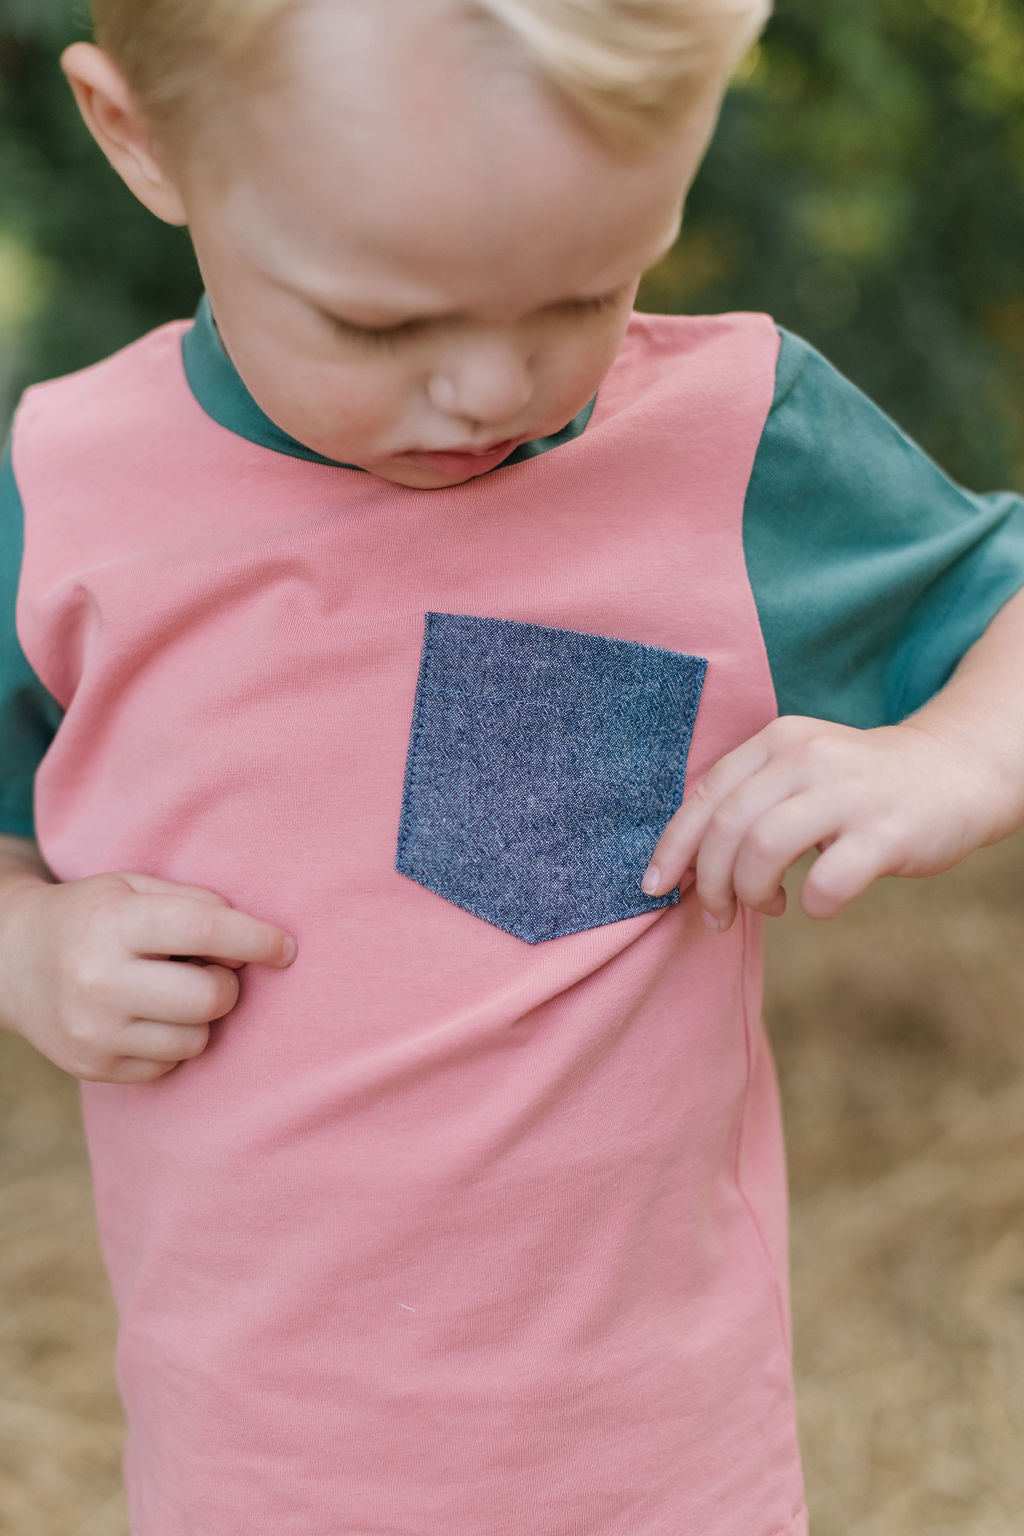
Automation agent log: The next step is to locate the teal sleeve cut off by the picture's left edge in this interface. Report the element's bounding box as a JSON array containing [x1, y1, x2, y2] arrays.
[[0, 433, 63, 837]]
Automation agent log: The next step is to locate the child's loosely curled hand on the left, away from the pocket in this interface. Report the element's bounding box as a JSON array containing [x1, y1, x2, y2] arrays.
[[0, 872, 295, 1083]]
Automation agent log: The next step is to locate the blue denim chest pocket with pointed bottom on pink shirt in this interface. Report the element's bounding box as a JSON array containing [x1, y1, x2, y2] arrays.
[[395, 613, 708, 945]]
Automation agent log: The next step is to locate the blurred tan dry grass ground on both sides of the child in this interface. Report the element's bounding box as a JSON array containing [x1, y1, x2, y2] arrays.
[[0, 837, 1024, 1536]]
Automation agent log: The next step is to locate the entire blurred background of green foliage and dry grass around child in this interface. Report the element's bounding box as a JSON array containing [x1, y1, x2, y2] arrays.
[[0, 0, 1024, 1536]]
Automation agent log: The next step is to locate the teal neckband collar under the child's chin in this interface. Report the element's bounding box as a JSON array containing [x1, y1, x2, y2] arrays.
[[181, 293, 597, 475]]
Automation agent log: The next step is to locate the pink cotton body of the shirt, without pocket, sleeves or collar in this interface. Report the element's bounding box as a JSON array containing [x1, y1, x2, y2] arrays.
[[14, 315, 806, 1536]]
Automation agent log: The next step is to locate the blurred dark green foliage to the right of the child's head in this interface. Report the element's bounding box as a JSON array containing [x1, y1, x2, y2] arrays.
[[643, 0, 1024, 485]]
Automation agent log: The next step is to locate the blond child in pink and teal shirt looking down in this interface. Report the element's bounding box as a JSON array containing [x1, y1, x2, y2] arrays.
[[0, 0, 1024, 1536]]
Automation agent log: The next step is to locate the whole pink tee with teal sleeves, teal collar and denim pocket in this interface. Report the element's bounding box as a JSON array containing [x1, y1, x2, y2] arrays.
[[0, 307, 1024, 1536]]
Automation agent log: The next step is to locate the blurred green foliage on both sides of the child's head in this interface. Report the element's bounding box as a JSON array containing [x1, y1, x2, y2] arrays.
[[0, 0, 1024, 487]]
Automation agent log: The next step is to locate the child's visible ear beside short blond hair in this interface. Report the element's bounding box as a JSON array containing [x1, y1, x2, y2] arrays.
[[60, 43, 187, 224]]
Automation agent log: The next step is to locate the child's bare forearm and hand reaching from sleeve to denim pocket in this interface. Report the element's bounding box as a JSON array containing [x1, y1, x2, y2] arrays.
[[645, 591, 1024, 929]]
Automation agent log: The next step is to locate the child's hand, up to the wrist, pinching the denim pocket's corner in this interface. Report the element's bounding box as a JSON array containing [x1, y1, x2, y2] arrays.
[[645, 714, 1006, 931]]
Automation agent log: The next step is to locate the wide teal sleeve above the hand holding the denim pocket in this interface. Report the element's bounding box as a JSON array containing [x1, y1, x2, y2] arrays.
[[743, 330, 1024, 727]]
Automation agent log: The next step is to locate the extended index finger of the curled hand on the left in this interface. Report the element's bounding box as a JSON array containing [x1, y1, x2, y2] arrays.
[[126, 894, 298, 969]]
